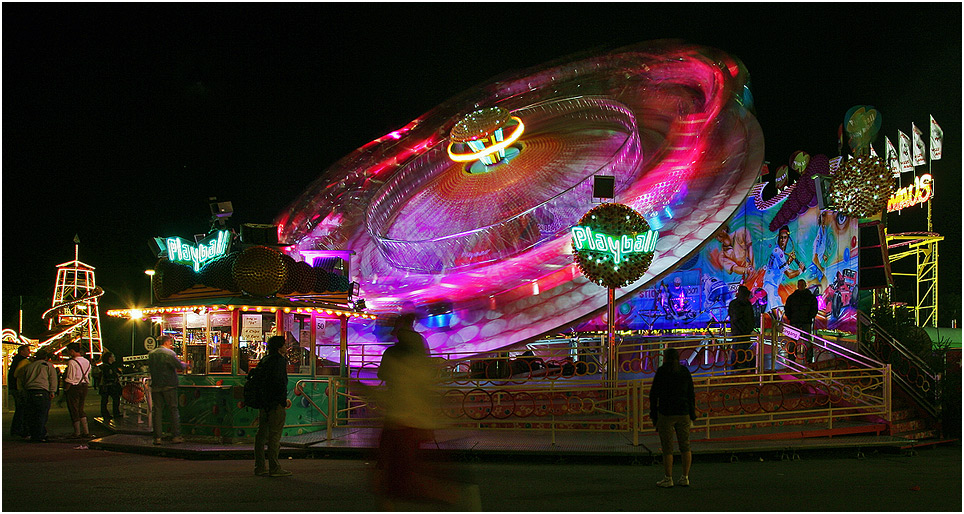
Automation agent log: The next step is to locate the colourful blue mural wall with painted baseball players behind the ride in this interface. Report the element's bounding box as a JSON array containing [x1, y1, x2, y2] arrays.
[[577, 195, 857, 332]]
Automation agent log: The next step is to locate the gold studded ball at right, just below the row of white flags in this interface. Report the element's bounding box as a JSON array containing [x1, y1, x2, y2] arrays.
[[829, 156, 894, 218]]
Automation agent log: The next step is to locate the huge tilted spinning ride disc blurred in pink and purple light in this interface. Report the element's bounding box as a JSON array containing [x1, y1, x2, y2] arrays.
[[276, 41, 763, 353]]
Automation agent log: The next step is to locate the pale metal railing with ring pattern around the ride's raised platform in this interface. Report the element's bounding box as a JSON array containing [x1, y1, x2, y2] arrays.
[[296, 324, 891, 444]]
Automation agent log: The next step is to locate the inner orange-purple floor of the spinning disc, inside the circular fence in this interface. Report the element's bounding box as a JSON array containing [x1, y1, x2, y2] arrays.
[[368, 97, 639, 273]]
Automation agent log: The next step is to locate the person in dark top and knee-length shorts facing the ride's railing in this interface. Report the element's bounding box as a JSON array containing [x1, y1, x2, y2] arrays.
[[649, 348, 696, 487]]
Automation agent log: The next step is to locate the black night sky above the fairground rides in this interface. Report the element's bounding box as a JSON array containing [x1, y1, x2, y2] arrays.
[[2, 3, 962, 352]]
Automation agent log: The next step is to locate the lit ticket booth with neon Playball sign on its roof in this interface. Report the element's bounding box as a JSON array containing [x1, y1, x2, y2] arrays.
[[108, 231, 375, 442]]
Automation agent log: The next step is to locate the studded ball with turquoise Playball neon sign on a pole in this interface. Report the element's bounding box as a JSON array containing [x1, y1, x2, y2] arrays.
[[572, 203, 658, 287]]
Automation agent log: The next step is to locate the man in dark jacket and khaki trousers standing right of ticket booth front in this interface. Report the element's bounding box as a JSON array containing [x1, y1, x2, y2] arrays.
[[254, 336, 291, 477]]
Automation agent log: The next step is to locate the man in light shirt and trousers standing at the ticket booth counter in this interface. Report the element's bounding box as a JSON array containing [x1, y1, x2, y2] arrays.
[[147, 335, 187, 444]]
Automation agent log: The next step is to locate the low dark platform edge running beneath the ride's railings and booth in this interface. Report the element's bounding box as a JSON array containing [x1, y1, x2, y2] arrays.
[[88, 418, 911, 463]]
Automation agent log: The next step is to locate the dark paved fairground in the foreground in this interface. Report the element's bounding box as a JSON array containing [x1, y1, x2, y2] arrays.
[[2, 388, 962, 512]]
